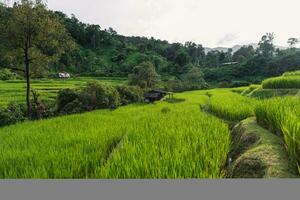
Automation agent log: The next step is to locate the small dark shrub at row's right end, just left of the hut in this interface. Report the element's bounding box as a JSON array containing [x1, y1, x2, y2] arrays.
[[117, 85, 143, 105]]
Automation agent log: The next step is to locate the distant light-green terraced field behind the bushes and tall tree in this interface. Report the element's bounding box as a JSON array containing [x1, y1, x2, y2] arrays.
[[0, 77, 126, 107]]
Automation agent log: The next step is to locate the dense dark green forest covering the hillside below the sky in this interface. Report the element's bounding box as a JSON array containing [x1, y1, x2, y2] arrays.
[[0, 1, 300, 86]]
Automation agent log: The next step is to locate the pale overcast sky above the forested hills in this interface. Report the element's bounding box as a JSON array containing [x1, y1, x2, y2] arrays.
[[48, 0, 300, 47]]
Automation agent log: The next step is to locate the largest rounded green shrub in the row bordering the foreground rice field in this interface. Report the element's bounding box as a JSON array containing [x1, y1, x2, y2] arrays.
[[79, 81, 120, 111]]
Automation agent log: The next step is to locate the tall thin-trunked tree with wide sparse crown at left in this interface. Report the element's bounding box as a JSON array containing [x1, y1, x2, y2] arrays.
[[5, 0, 74, 116]]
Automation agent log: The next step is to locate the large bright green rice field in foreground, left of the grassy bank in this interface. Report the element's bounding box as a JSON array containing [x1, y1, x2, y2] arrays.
[[0, 92, 230, 178]]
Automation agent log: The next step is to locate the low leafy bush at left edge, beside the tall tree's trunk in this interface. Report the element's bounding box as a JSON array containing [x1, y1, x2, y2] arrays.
[[0, 103, 26, 127]]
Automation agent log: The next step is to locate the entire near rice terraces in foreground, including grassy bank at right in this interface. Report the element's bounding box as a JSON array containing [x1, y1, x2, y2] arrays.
[[0, 72, 300, 178]]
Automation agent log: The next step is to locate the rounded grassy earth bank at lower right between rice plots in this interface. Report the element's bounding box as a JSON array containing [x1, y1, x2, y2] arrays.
[[228, 118, 297, 178]]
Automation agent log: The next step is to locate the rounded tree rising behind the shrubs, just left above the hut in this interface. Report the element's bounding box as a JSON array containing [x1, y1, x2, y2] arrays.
[[129, 62, 159, 88]]
